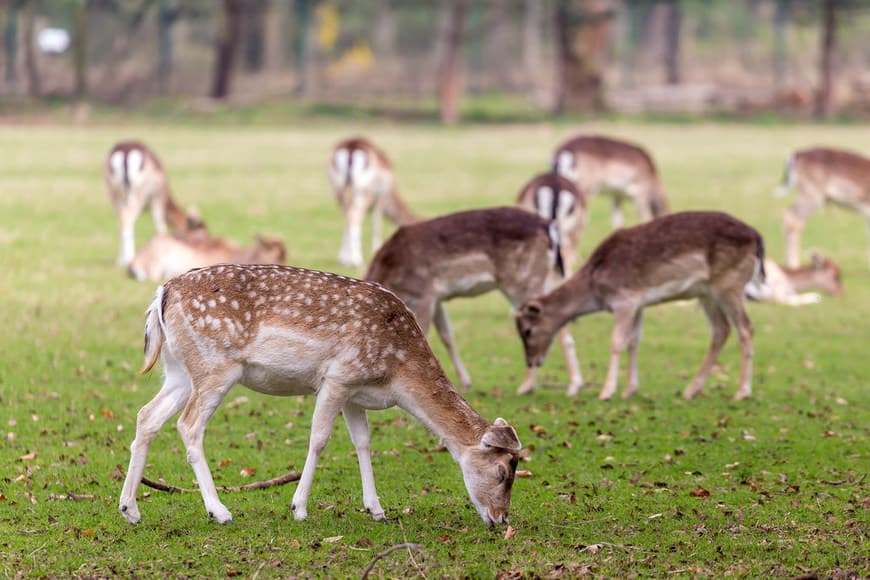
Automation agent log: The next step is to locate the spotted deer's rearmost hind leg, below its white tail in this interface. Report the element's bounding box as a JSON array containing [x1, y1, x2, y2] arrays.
[[118, 351, 190, 524]]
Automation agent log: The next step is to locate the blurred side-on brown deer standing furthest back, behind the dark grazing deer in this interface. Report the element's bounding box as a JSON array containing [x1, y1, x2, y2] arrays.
[[553, 135, 668, 229]]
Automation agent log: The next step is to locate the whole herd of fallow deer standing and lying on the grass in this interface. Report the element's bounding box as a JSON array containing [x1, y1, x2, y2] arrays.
[[104, 135, 870, 525]]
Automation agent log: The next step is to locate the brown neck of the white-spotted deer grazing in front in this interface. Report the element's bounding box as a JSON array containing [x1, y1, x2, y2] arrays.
[[397, 368, 489, 461]]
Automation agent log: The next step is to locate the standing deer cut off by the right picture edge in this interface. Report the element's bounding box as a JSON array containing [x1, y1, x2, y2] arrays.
[[776, 147, 870, 268]]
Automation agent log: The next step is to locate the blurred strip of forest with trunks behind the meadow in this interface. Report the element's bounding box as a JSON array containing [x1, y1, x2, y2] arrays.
[[0, 0, 870, 122]]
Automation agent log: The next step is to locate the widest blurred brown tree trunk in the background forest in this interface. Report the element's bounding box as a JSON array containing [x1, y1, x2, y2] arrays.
[[555, 0, 613, 114]]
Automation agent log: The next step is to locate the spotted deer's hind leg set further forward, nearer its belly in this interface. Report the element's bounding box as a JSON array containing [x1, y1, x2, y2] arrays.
[[177, 369, 238, 524]]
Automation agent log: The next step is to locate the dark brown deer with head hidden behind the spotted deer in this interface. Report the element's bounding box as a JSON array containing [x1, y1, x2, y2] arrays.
[[366, 207, 583, 394]]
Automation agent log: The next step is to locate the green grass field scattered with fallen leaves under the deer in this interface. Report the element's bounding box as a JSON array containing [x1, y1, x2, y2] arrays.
[[0, 119, 870, 577]]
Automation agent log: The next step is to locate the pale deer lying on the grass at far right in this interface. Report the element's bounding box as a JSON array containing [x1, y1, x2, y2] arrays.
[[746, 254, 843, 306]]
